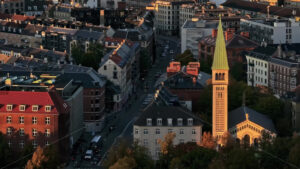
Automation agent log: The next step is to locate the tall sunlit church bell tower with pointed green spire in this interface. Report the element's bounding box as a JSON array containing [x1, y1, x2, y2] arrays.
[[211, 17, 229, 142]]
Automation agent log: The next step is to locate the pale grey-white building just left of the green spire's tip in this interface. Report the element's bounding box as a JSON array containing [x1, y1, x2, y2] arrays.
[[180, 18, 218, 56]]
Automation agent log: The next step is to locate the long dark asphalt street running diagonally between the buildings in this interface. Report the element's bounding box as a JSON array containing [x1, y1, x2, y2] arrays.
[[67, 37, 180, 169]]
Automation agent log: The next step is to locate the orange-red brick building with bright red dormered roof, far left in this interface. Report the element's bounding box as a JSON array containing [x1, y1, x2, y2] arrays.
[[0, 88, 70, 153]]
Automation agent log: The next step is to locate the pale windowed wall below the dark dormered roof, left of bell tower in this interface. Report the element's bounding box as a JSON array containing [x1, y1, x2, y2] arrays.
[[133, 125, 202, 160]]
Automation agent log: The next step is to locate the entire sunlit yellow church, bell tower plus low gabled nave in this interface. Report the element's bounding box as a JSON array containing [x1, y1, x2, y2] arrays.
[[212, 19, 276, 144]]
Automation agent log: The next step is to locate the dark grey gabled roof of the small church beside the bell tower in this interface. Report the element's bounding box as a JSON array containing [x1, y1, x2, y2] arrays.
[[228, 106, 276, 133]]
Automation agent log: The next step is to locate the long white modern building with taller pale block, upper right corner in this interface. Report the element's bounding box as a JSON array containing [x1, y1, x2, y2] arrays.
[[240, 19, 300, 44]]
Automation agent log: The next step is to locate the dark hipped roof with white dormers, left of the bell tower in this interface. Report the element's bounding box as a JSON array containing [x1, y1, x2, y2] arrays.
[[134, 105, 203, 126]]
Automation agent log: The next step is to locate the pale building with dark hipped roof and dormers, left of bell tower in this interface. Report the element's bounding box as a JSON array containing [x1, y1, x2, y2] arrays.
[[133, 106, 203, 160]]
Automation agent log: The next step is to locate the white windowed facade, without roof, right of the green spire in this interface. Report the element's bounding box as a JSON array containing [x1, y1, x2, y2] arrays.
[[246, 55, 269, 87]]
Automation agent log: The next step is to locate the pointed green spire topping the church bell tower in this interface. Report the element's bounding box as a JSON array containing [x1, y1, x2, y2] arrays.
[[211, 17, 229, 70]]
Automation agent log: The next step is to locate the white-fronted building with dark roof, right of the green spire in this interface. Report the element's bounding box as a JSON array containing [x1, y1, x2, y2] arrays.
[[246, 46, 276, 87]]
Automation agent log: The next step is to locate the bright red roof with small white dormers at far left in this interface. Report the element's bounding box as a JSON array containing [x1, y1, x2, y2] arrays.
[[0, 90, 69, 114]]
